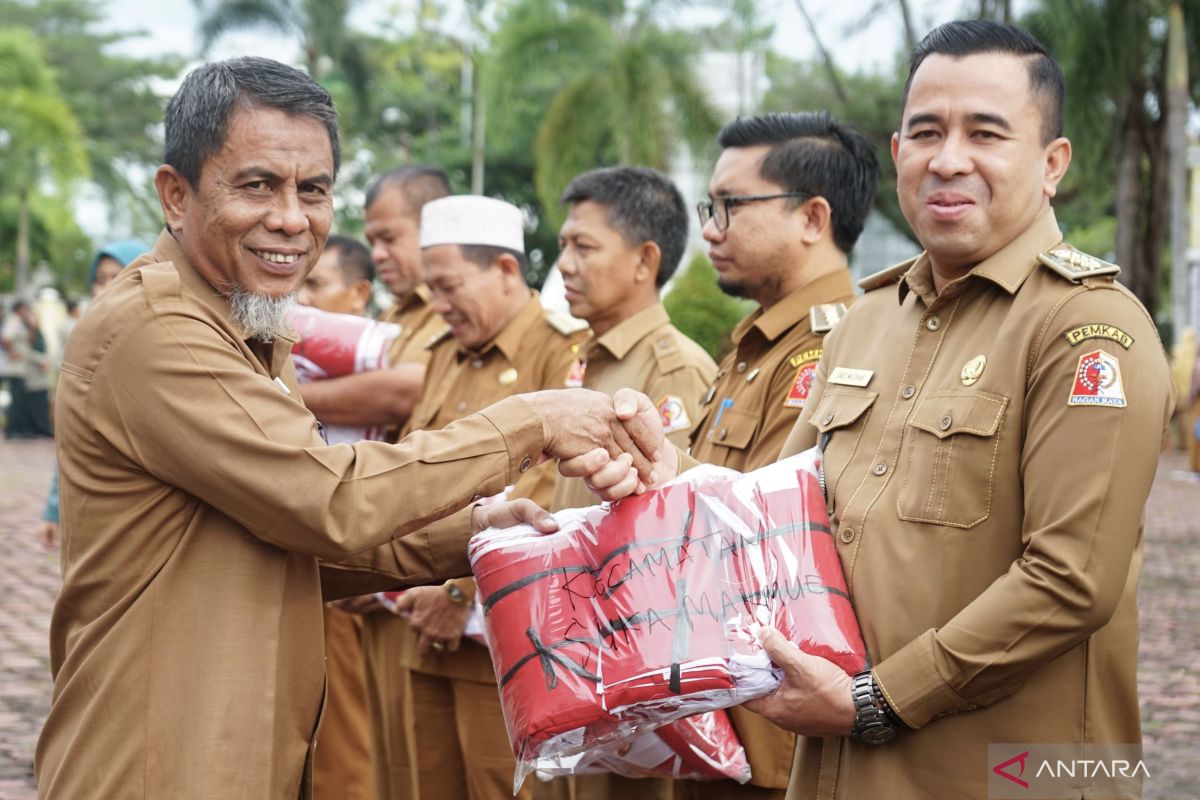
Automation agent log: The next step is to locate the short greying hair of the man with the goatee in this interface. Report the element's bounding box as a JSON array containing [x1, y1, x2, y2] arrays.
[[163, 55, 342, 187]]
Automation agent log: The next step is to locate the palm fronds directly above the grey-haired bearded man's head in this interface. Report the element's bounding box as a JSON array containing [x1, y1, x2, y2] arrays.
[[192, 0, 370, 115]]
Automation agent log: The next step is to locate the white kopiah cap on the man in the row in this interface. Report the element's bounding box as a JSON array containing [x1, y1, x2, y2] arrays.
[[421, 194, 524, 253]]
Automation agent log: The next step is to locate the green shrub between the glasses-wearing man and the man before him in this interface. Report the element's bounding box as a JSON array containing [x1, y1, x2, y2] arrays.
[[662, 254, 755, 361]]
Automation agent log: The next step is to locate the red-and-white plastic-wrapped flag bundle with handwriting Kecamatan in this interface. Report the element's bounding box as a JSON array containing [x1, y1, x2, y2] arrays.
[[470, 449, 866, 784]]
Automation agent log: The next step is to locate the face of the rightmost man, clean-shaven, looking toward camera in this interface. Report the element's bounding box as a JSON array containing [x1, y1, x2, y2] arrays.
[[892, 53, 1070, 277]]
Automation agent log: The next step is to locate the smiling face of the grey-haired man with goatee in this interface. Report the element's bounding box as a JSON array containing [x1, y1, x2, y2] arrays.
[[155, 106, 334, 297]]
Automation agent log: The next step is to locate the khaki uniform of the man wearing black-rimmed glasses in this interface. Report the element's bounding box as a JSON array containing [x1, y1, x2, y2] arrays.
[[677, 270, 854, 800]]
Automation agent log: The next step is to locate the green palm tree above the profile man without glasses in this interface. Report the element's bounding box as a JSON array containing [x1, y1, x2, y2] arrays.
[[488, 0, 720, 215]]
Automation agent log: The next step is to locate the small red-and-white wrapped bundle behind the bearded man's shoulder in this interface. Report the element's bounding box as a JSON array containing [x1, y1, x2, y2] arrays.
[[288, 306, 401, 445]]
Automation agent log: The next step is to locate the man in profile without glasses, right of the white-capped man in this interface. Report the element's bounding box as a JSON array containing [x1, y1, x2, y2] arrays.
[[552, 167, 716, 800]]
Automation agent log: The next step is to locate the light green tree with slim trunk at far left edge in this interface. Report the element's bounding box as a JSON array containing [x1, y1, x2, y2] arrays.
[[0, 28, 88, 294]]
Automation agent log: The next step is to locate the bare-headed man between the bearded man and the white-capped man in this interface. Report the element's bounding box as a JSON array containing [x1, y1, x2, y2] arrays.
[[304, 166, 450, 434]]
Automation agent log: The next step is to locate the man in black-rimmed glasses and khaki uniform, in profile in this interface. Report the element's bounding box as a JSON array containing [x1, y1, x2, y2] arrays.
[[686, 113, 878, 798]]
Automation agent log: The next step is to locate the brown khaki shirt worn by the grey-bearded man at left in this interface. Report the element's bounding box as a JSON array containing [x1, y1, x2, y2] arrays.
[[36, 234, 542, 800]]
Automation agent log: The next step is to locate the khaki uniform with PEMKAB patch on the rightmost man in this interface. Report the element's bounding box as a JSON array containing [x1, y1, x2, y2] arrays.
[[782, 210, 1172, 800]]
